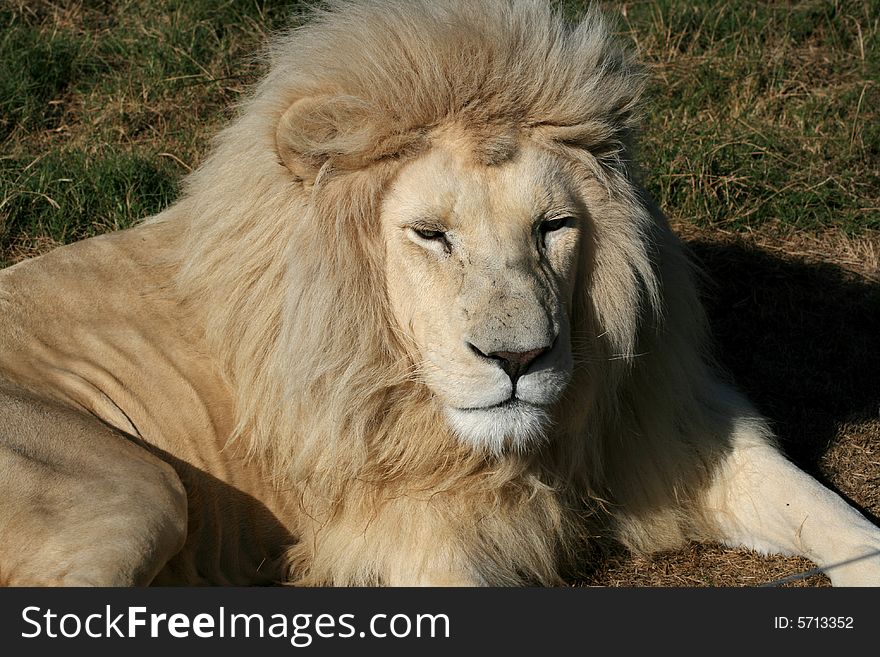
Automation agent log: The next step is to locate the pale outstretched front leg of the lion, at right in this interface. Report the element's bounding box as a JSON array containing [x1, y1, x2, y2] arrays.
[[705, 430, 880, 586]]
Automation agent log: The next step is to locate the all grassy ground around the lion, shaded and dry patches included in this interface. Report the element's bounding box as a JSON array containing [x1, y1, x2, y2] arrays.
[[0, 0, 880, 586]]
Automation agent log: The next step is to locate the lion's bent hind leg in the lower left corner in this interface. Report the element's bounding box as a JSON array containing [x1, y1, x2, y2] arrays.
[[0, 389, 187, 586]]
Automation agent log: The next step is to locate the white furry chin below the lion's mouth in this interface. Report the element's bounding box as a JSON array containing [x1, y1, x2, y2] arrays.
[[445, 400, 550, 454]]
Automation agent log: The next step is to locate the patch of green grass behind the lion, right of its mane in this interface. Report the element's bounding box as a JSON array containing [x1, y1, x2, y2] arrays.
[[621, 0, 880, 233]]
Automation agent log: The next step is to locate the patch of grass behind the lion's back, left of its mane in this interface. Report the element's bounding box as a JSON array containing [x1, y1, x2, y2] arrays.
[[0, 0, 295, 266]]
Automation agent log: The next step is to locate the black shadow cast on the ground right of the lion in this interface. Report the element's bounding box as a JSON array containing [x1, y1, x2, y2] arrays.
[[688, 241, 880, 471]]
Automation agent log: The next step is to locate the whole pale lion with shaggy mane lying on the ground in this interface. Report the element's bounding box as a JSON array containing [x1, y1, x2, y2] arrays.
[[0, 0, 880, 585]]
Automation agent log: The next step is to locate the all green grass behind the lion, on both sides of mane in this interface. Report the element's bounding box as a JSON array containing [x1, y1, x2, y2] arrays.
[[0, 0, 880, 265]]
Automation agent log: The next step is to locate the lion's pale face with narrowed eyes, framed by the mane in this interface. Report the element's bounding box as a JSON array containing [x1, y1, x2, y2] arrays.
[[382, 139, 586, 451]]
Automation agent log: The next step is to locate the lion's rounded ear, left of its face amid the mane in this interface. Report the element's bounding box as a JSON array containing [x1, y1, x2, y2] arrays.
[[275, 95, 377, 185]]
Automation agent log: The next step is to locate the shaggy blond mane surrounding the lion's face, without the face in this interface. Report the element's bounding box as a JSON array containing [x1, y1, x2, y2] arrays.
[[156, 0, 764, 584]]
